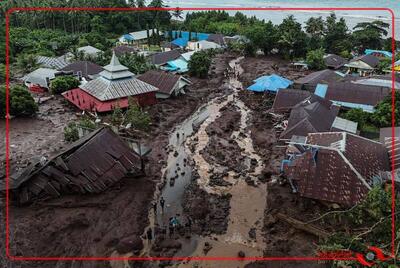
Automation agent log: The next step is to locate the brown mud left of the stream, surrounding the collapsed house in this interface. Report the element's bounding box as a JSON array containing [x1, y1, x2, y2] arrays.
[[0, 52, 232, 268]]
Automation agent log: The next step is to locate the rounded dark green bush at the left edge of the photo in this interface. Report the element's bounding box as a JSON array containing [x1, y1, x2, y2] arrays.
[[0, 86, 38, 117]]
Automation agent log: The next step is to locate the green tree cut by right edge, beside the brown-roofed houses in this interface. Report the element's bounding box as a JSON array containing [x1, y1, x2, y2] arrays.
[[371, 92, 400, 127]]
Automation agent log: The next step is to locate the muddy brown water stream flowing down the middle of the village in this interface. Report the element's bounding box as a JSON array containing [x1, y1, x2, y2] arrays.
[[136, 58, 266, 267]]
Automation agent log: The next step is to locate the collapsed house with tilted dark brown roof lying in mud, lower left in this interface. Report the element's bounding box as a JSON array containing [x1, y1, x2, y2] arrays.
[[0, 128, 144, 204]]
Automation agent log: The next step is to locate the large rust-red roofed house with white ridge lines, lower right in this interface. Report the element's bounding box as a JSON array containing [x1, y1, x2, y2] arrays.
[[282, 132, 389, 206]]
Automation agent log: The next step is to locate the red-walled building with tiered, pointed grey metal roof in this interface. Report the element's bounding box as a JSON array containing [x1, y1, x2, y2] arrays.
[[62, 53, 158, 112]]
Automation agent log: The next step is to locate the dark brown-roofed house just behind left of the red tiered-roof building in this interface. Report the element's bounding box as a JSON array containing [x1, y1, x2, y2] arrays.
[[60, 60, 103, 82]]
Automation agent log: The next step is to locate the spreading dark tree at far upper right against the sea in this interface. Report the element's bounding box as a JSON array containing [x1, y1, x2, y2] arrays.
[[352, 21, 391, 53]]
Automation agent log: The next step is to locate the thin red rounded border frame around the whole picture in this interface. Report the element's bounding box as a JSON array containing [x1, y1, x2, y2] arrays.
[[5, 7, 395, 261]]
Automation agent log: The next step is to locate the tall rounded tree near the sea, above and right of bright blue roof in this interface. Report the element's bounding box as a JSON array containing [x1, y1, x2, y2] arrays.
[[277, 15, 307, 59]]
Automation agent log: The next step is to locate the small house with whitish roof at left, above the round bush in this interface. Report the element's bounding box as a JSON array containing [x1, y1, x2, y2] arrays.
[[22, 68, 60, 92]]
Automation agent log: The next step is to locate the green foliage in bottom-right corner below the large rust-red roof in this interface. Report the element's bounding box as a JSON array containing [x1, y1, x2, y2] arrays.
[[320, 186, 400, 267]]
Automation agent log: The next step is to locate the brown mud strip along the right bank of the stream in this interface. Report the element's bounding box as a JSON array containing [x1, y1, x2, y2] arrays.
[[240, 57, 326, 268]]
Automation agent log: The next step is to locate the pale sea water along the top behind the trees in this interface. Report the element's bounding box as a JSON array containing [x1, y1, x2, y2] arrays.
[[165, 0, 400, 40]]
